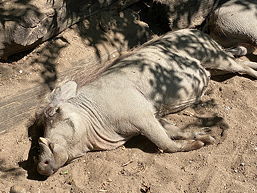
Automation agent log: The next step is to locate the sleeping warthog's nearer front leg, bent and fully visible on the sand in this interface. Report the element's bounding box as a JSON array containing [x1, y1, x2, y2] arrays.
[[133, 113, 210, 152]]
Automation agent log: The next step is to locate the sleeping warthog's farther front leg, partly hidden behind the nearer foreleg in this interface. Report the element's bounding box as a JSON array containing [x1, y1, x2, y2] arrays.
[[159, 119, 215, 144]]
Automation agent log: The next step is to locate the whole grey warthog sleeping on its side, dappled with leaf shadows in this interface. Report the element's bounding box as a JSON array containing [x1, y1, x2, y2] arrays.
[[38, 29, 257, 176]]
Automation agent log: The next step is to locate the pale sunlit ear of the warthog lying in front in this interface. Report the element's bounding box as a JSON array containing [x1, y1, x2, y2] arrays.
[[50, 81, 77, 106]]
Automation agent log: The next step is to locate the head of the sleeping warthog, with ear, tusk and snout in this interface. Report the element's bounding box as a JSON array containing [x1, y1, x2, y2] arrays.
[[37, 81, 77, 176]]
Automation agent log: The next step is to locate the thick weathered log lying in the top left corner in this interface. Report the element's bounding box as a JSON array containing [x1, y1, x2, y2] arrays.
[[0, 0, 139, 60]]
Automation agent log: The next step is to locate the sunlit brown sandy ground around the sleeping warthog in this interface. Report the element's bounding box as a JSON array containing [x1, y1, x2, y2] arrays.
[[0, 7, 257, 193]]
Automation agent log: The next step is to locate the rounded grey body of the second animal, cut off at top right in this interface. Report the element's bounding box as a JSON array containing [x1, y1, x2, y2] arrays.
[[209, 0, 257, 56]]
